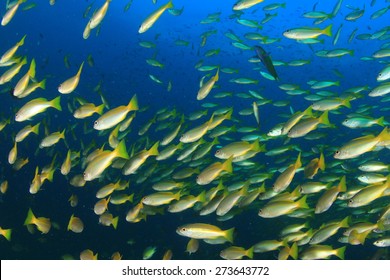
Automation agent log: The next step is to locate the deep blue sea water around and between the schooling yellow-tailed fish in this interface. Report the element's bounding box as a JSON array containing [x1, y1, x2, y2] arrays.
[[0, 0, 390, 259]]
